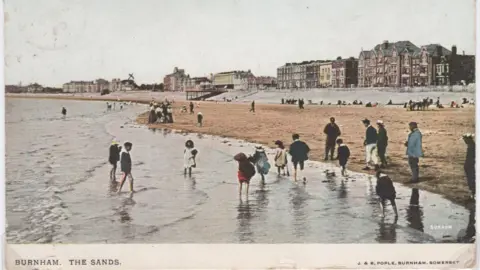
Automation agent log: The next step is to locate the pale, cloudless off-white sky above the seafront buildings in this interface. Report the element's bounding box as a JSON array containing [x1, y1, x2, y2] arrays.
[[4, 0, 475, 87]]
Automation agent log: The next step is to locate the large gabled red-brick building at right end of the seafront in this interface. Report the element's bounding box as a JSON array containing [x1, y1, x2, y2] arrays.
[[358, 41, 475, 87]]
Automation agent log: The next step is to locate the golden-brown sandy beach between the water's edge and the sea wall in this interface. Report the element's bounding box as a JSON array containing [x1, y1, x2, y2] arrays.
[[137, 102, 475, 205]]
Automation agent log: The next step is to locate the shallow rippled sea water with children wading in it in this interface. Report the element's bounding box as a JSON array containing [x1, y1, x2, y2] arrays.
[[6, 99, 475, 243]]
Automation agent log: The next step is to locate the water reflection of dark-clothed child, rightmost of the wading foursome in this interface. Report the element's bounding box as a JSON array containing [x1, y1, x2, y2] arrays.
[[290, 185, 309, 238]]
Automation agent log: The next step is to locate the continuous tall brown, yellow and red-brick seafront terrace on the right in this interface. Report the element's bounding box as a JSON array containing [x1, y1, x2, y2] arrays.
[[277, 41, 475, 89]]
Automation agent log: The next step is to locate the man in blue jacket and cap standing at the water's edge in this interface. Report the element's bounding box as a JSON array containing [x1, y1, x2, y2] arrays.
[[405, 122, 423, 183]]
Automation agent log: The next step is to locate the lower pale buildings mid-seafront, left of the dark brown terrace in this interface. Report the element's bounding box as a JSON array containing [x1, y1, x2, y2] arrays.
[[163, 67, 277, 91]]
